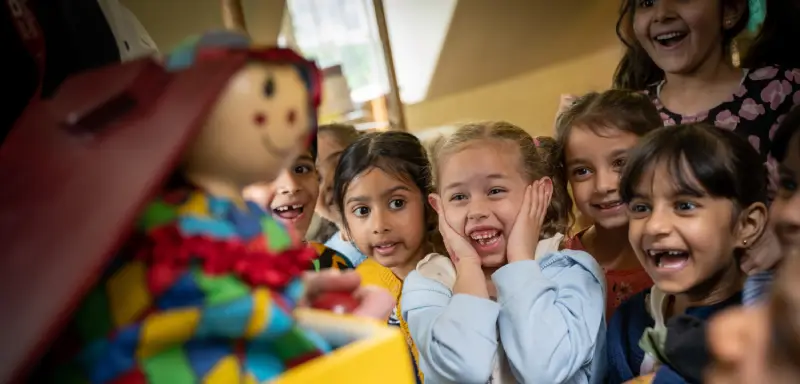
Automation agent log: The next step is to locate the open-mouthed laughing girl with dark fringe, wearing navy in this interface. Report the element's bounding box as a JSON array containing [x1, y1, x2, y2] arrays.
[[608, 124, 767, 383]]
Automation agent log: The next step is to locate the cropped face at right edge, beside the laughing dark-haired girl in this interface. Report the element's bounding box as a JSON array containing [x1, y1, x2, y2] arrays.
[[770, 133, 800, 249]]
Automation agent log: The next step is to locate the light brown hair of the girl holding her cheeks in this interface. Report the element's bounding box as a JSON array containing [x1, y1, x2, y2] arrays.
[[431, 121, 572, 238]]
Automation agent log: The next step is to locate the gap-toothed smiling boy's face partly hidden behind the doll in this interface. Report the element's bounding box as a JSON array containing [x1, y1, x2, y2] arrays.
[[245, 152, 319, 235]]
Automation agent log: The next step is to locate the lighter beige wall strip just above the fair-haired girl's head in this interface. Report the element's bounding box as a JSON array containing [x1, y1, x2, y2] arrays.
[[405, 44, 622, 136]]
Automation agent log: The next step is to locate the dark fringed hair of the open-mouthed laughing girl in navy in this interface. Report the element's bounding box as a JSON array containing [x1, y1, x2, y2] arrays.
[[620, 123, 767, 210]]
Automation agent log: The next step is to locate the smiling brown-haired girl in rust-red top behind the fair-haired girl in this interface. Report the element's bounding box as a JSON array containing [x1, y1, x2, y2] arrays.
[[556, 90, 661, 318]]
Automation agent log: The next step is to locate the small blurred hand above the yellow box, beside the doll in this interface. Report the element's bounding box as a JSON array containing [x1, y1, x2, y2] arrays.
[[301, 269, 397, 320]]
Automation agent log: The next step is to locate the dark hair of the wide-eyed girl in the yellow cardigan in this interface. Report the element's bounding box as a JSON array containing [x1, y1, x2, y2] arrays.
[[333, 131, 436, 231]]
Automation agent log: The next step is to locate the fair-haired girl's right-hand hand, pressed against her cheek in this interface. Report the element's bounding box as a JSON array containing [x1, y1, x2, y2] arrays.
[[506, 177, 553, 263]]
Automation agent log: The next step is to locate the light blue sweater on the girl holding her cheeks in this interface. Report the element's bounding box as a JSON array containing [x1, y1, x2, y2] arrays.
[[402, 250, 606, 384]]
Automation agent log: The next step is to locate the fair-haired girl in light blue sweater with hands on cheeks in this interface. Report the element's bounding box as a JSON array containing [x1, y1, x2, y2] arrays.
[[402, 122, 605, 383]]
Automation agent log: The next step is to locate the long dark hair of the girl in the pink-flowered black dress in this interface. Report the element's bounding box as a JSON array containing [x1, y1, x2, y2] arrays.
[[613, 0, 752, 91]]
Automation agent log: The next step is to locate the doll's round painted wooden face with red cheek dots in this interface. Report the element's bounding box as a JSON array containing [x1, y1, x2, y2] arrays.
[[184, 62, 311, 190]]
